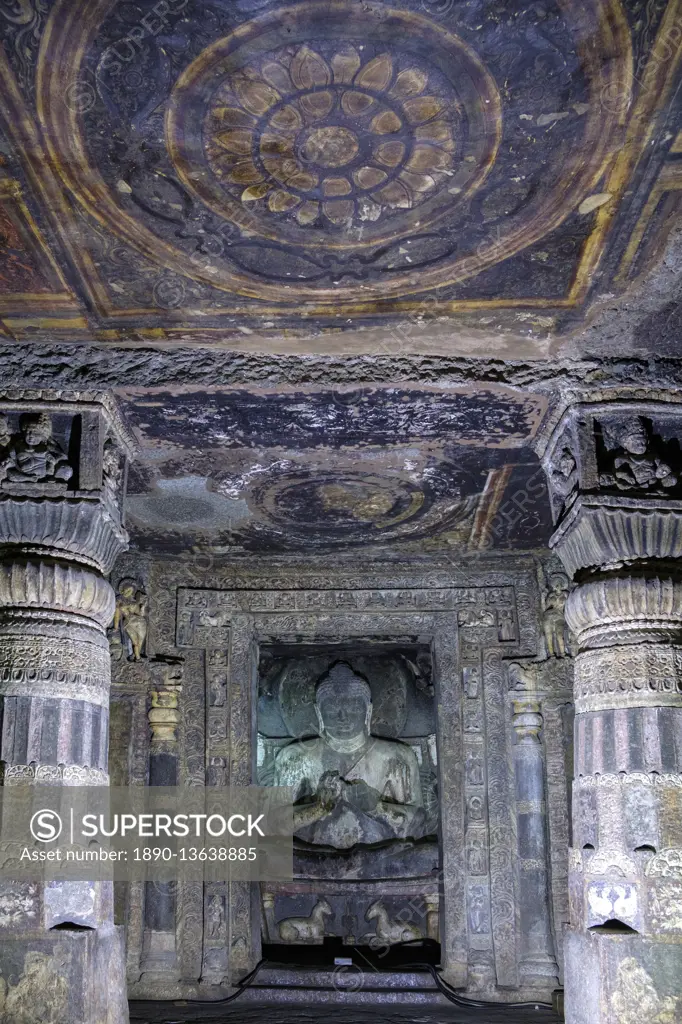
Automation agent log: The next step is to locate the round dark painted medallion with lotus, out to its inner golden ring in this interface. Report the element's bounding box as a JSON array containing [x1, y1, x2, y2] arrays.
[[167, 14, 501, 248]]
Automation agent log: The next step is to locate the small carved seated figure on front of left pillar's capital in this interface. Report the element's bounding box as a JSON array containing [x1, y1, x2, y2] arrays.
[[0, 413, 74, 487]]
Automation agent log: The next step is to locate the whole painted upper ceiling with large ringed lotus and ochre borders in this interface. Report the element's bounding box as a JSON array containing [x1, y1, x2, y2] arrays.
[[0, 0, 682, 348]]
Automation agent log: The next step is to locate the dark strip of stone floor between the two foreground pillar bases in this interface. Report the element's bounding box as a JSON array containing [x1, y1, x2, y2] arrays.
[[130, 999, 560, 1024]]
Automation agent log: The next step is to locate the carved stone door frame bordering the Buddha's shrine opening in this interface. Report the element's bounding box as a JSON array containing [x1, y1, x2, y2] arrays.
[[175, 566, 536, 987]]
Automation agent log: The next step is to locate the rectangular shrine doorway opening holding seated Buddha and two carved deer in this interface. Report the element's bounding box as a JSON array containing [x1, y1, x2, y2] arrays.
[[257, 642, 441, 964]]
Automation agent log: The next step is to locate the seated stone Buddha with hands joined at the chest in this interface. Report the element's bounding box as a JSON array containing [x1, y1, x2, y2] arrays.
[[274, 663, 425, 850]]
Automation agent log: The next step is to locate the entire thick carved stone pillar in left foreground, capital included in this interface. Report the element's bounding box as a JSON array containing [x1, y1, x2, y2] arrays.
[[0, 392, 131, 1024]]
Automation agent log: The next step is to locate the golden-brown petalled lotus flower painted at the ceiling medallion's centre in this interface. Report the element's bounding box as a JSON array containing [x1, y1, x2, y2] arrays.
[[205, 46, 461, 227]]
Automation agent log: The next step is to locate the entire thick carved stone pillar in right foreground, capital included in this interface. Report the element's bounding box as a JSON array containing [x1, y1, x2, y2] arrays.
[[543, 400, 682, 1024]]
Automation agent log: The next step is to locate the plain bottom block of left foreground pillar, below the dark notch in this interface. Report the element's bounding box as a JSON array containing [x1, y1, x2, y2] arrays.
[[0, 925, 129, 1024]]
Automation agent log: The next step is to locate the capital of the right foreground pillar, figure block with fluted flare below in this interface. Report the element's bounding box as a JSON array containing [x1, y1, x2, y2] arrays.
[[539, 398, 682, 577]]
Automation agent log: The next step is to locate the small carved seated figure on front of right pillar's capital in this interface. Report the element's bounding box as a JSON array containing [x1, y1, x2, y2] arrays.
[[598, 416, 679, 495]]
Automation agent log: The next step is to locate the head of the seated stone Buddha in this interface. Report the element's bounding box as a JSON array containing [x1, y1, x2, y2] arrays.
[[315, 662, 372, 749]]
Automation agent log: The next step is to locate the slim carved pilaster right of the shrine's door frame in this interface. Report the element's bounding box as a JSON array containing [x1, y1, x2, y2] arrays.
[[512, 699, 559, 991]]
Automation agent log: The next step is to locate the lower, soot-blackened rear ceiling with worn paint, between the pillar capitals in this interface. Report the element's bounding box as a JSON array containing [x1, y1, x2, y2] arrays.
[[122, 387, 550, 559]]
